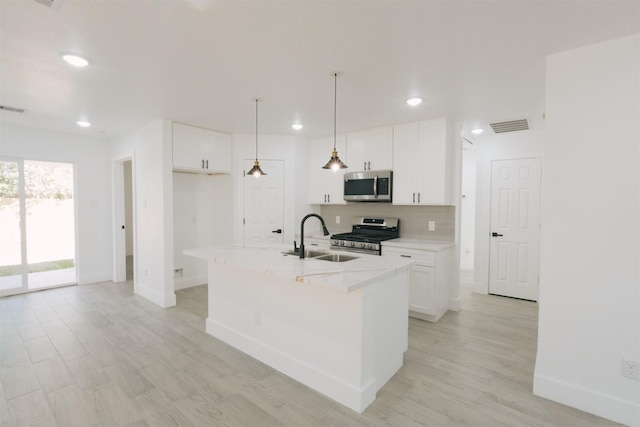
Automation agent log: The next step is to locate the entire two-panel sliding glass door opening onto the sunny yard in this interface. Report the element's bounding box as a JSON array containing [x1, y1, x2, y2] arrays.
[[0, 159, 76, 295]]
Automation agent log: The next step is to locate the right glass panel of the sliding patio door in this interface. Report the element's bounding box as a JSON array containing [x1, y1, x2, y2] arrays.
[[24, 160, 76, 289]]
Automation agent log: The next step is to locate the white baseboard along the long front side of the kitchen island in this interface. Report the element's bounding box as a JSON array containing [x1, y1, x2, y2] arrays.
[[206, 318, 376, 413]]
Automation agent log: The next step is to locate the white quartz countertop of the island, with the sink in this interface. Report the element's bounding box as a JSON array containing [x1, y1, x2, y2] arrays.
[[184, 246, 413, 292]]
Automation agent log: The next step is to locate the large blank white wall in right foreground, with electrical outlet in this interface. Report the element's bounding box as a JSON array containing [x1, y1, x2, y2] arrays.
[[534, 34, 640, 426]]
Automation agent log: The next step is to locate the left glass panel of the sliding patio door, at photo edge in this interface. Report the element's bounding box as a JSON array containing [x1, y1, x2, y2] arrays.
[[0, 160, 26, 293]]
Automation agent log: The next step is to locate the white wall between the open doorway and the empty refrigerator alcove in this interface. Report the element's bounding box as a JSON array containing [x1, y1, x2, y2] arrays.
[[109, 120, 176, 307]]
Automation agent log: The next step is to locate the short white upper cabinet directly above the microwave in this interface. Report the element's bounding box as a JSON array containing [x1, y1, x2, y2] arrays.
[[346, 126, 393, 171]]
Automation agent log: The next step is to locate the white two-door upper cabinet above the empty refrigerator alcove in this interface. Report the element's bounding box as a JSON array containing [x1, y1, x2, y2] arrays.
[[173, 123, 231, 174]]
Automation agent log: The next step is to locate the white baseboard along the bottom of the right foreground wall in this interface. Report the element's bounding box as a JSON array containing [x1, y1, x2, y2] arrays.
[[533, 374, 640, 427]]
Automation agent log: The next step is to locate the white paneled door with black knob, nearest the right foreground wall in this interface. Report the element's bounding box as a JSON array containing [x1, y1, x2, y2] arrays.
[[489, 158, 541, 301]]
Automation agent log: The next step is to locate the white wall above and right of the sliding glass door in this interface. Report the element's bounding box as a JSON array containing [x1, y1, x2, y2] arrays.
[[0, 125, 112, 284]]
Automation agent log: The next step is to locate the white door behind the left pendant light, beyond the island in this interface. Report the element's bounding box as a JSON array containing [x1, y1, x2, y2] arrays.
[[244, 160, 284, 246]]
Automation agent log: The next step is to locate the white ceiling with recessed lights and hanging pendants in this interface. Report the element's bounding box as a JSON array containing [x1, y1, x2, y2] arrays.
[[0, 0, 640, 138]]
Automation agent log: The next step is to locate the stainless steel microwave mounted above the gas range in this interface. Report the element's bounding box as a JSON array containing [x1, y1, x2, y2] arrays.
[[344, 170, 393, 202]]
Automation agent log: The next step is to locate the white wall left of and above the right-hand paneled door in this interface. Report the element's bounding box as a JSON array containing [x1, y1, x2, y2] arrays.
[[473, 129, 545, 294]]
